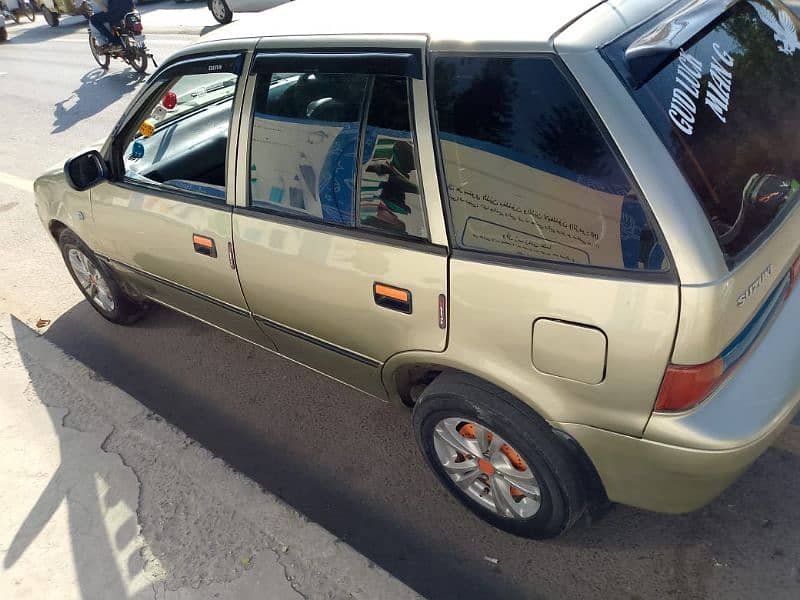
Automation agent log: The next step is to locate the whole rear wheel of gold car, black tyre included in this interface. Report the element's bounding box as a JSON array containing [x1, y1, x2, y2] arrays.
[[413, 372, 588, 539]]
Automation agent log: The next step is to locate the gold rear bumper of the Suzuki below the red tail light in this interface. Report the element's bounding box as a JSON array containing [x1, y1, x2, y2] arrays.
[[554, 278, 800, 513]]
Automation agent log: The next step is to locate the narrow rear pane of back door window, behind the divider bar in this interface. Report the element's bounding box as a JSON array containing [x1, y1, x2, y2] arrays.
[[359, 77, 427, 238]]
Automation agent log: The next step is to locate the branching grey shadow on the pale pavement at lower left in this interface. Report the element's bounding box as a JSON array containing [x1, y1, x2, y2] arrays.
[[3, 317, 153, 600]]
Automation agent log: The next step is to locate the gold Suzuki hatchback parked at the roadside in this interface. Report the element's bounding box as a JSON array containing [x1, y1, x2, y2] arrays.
[[35, 0, 800, 537]]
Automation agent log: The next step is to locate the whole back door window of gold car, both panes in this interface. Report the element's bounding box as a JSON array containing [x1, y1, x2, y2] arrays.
[[249, 73, 427, 238]]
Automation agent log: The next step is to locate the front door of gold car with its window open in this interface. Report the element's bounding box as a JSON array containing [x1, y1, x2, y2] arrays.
[[91, 53, 274, 348]]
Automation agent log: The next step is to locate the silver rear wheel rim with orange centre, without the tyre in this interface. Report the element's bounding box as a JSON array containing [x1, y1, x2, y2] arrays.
[[433, 417, 541, 519]]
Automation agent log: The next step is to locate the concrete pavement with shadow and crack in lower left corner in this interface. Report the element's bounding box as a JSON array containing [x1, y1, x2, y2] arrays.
[[0, 315, 417, 600]]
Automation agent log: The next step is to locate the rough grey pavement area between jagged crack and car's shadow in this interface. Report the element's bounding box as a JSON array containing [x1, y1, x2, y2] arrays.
[[0, 314, 418, 600]]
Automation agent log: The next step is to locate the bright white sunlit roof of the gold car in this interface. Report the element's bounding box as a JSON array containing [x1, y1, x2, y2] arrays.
[[202, 0, 603, 44]]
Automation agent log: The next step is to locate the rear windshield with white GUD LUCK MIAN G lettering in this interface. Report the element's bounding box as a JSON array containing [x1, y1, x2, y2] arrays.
[[603, 0, 800, 265]]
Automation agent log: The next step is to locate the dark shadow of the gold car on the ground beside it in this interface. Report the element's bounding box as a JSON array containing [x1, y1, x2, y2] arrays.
[[36, 303, 800, 599]]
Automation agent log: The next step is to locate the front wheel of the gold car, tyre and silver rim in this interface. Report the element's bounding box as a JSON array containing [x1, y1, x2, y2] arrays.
[[58, 229, 147, 325]]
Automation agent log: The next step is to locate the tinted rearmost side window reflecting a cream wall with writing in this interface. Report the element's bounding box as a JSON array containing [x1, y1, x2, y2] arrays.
[[434, 57, 666, 270]]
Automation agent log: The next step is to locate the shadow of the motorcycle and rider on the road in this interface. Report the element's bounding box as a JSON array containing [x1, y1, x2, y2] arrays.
[[51, 68, 147, 133]]
